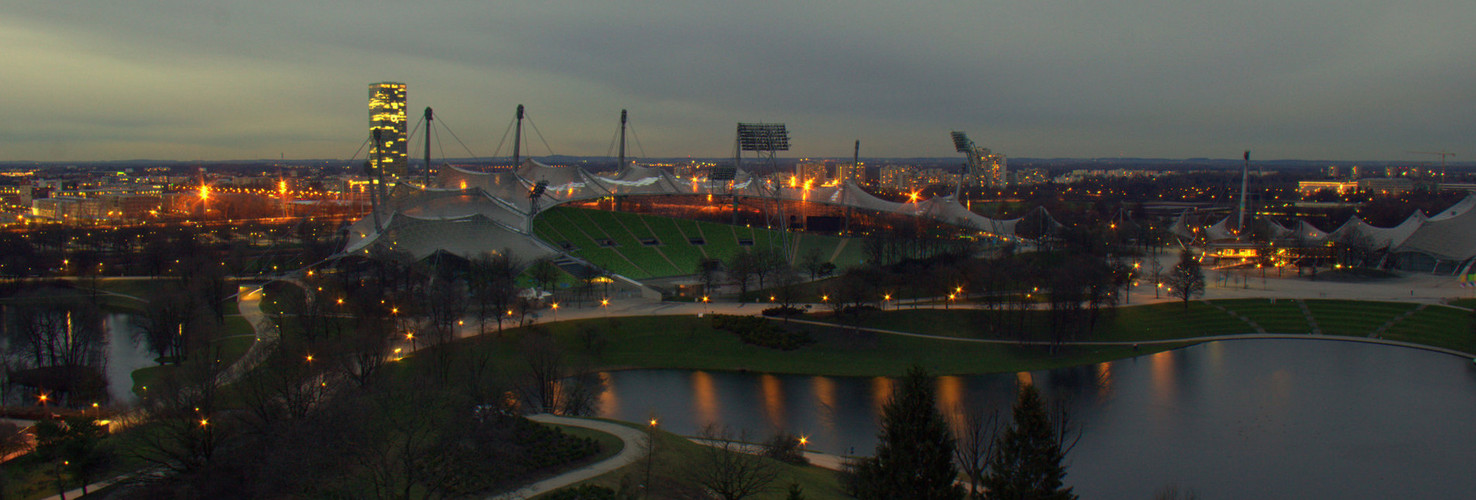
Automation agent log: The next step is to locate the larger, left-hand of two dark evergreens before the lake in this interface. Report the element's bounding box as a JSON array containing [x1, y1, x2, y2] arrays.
[[855, 366, 964, 499]]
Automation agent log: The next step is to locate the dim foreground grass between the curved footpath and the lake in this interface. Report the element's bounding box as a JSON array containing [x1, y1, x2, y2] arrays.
[[563, 420, 849, 499]]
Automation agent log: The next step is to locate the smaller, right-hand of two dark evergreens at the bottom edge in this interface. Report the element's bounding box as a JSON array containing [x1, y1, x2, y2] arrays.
[[984, 385, 1076, 500]]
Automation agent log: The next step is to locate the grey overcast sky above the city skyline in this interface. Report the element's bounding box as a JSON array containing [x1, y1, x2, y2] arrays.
[[0, 0, 1476, 161]]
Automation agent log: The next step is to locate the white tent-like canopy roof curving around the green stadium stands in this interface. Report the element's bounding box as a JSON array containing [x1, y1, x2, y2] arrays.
[[345, 159, 1060, 260]]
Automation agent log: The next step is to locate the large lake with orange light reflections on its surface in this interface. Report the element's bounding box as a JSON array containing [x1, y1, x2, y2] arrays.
[[598, 341, 1476, 499]]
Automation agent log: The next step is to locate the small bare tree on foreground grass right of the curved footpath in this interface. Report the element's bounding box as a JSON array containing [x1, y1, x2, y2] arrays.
[[691, 426, 779, 500]]
